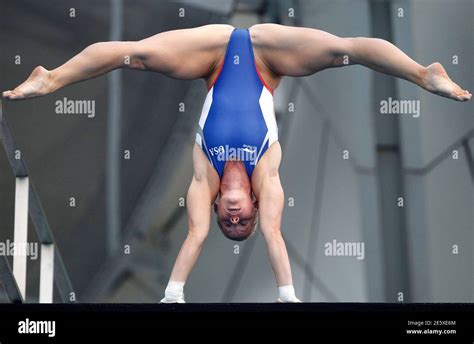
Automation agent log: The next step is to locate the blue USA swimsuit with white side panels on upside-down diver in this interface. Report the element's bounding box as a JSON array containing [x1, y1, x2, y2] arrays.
[[196, 29, 278, 177]]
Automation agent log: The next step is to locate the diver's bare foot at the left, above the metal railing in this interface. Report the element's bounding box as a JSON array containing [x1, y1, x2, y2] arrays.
[[2, 66, 53, 100]]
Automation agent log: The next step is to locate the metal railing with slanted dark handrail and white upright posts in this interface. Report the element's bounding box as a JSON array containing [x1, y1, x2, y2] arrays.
[[0, 99, 77, 303]]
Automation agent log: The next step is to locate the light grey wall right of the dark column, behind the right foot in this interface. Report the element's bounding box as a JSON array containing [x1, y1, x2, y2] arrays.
[[393, 0, 474, 302]]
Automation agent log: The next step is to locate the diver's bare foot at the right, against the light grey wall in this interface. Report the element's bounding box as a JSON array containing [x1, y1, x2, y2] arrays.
[[422, 62, 472, 102]]
